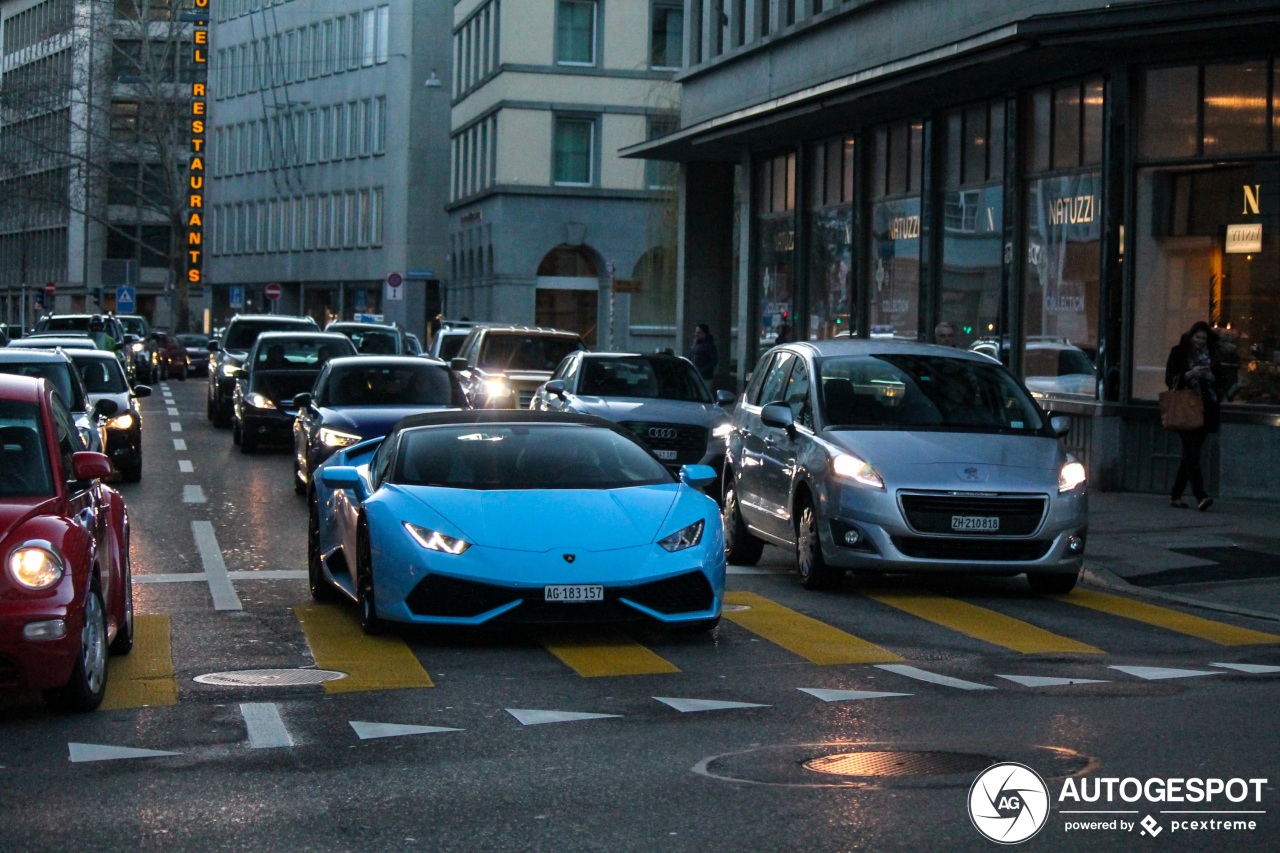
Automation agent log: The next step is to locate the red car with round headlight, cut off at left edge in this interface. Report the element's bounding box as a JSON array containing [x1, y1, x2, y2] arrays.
[[0, 375, 133, 711]]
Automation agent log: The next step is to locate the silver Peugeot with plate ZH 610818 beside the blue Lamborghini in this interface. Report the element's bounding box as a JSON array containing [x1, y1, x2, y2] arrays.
[[723, 339, 1088, 593]]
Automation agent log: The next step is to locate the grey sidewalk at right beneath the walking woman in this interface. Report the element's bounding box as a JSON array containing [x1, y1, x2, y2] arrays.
[[1082, 492, 1280, 621]]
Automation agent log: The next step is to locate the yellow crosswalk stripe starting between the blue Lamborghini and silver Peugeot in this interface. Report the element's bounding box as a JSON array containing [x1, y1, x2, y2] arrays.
[[724, 592, 902, 666]]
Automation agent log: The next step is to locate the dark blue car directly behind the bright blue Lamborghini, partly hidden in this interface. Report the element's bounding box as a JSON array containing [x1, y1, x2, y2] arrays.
[[293, 356, 468, 494]]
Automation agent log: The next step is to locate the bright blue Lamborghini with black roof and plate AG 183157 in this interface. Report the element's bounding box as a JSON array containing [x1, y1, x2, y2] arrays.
[[307, 410, 724, 633]]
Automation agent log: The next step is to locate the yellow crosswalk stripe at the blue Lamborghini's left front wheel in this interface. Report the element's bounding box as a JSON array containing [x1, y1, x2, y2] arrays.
[[293, 606, 435, 693]]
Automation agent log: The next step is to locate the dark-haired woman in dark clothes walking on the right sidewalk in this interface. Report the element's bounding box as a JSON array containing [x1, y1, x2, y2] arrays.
[[1165, 320, 1222, 504]]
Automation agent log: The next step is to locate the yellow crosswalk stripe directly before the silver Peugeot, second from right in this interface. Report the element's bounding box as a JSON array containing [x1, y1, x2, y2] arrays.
[[863, 592, 1103, 654]]
